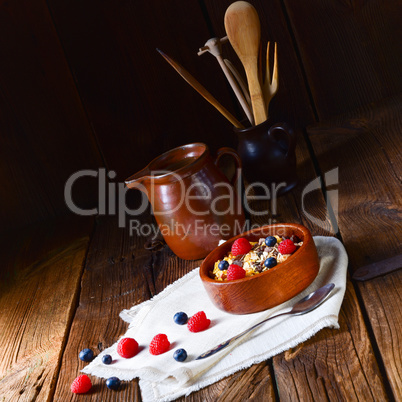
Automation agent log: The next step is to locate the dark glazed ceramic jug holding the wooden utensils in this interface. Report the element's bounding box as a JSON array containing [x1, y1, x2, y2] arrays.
[[234, 120, 297, 196]]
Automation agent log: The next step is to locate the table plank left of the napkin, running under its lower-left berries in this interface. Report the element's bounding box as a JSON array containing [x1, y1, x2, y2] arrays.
[[54, 216, 153, 401]]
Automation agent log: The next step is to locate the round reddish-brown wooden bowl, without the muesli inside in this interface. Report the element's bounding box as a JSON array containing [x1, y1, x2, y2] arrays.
[[200, 223, 319, 314]]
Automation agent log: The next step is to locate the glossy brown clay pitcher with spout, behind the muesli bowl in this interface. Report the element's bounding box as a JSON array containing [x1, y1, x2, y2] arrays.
[[125, 143, 245, 260]]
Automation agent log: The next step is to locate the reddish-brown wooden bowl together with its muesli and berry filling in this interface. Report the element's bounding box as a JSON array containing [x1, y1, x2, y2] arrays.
[[200, 223, 320, 314]]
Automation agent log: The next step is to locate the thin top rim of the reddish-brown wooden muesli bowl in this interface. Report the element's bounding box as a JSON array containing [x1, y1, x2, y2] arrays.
[[199, 223, 313, 286]]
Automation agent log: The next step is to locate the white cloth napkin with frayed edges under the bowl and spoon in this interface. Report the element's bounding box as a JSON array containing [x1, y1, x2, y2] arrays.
[[82, 236, 348, 402]]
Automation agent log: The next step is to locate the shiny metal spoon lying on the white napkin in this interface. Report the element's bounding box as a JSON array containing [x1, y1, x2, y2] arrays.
[[196, 283, 335, 360]]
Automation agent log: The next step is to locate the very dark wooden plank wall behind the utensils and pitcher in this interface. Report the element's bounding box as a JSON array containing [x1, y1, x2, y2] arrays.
[[0, 0, 402, 233]]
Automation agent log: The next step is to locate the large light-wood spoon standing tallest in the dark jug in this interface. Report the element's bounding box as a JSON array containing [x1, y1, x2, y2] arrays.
[[225, 1, 267, 125]]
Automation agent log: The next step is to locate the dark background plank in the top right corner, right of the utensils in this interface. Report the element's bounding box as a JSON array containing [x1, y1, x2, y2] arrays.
[[284, 0, 402, 120]]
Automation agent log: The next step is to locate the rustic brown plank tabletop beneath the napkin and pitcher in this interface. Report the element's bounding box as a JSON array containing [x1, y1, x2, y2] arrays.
[[0, 99, 402, 401]]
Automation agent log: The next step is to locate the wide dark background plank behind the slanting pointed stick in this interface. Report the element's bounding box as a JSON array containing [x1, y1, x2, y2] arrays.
[[49, 0, 242, 179]]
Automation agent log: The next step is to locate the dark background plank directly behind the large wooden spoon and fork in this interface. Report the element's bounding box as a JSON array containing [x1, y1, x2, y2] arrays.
[[203, 0, 315, 128]]
